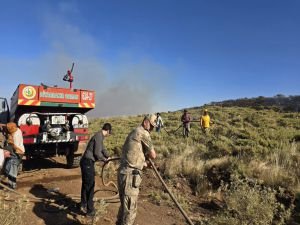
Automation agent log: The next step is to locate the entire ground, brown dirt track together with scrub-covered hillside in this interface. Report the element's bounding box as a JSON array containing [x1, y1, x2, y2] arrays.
[[0, 105, 300, 225]]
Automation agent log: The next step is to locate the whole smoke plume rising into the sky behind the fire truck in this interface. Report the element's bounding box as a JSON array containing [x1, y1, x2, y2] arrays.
[[0, 5, 171, 117]]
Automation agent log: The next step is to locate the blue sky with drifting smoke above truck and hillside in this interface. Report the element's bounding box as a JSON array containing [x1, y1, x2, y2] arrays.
[[0, 0, 300, 116]]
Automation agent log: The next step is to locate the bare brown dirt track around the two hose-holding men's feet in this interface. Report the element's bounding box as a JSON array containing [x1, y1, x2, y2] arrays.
[[3, 157, 207, 225]]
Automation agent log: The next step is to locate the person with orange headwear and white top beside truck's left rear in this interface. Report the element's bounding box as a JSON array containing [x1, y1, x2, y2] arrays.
[[4, 122, 25, 189]]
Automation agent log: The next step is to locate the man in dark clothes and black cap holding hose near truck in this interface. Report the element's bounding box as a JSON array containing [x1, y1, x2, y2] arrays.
[[80, 123, 112, 217]]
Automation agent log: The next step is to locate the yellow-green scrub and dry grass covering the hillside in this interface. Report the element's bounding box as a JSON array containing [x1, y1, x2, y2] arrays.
[[91, 105, 300, 225]]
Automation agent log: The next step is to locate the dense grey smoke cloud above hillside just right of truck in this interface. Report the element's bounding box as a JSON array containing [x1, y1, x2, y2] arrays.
[[92, 62, 169, 116]]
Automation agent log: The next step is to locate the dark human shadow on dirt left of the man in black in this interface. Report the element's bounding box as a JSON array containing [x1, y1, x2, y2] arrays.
[[29, 184, 82, 225]]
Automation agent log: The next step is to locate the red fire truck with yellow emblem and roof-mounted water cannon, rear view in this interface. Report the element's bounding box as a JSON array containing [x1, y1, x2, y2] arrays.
[[0, 64, 95, 167]]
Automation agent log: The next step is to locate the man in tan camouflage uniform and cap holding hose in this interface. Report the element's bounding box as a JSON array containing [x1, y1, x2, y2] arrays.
[[116, 114, 156, 225]]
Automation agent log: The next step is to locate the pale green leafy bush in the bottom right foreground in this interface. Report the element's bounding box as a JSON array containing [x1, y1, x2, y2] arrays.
[[208, 176, 290, 225]]
